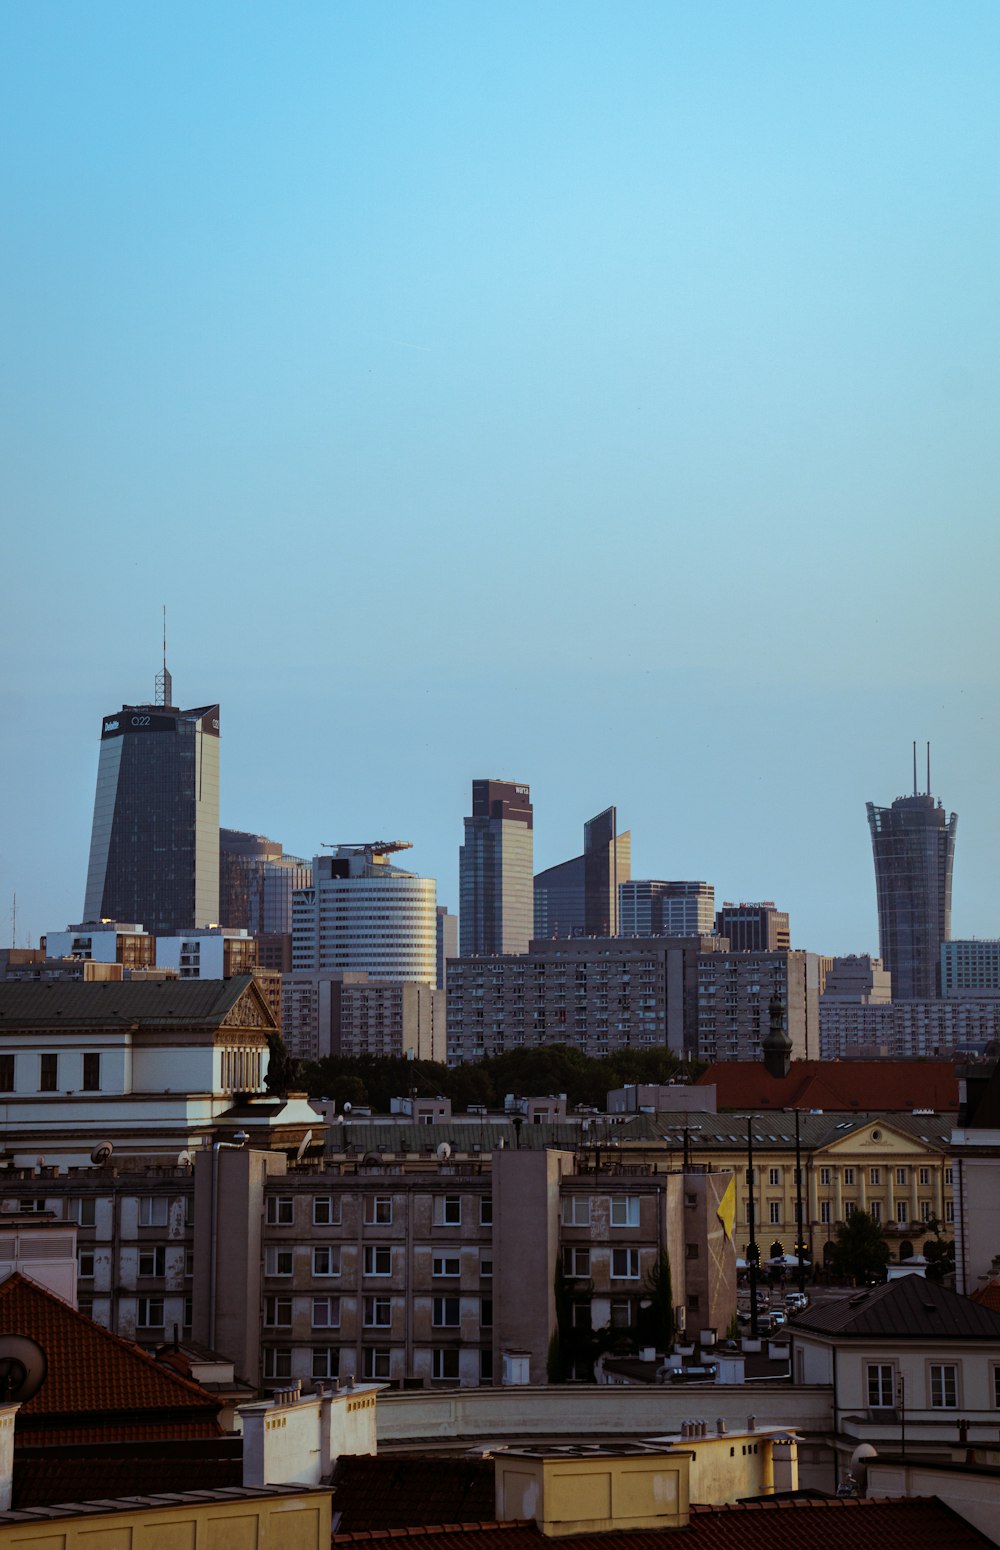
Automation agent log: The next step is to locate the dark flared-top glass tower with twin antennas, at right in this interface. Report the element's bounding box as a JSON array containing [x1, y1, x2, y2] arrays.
[[868, 755, 958, 1001]]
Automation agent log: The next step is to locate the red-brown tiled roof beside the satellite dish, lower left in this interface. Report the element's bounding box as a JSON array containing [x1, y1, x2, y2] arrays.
[[0, 1271, 222, 1445]]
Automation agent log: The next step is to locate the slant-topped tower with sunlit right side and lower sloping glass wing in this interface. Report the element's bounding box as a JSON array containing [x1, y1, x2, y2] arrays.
[[535, 808, 632, 938]]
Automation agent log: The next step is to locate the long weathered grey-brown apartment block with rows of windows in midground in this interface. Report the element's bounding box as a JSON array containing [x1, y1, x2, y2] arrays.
[[2, 1145, 735, 1387]]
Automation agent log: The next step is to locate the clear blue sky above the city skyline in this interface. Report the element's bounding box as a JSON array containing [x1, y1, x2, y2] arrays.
[[0, 0, 1000, 952]]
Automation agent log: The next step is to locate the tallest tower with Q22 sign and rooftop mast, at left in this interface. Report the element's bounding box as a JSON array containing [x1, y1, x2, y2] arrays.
[[84, 667, 219, 935]]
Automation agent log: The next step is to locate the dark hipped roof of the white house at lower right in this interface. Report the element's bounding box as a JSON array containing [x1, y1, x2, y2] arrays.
[[794, 1276, 1000, 1344]]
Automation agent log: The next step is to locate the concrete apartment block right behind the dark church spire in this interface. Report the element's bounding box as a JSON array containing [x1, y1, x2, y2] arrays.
[[696, 950, 820, 1062]]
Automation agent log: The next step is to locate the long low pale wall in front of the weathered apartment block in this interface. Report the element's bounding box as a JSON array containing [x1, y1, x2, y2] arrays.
[[375, 1384, 833, 1448]]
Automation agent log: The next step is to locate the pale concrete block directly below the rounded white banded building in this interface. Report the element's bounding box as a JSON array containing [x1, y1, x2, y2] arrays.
[[282, 969, 447, 1062]]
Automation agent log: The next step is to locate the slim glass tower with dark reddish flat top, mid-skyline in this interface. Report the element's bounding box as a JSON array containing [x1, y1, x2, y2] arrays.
[[459, 780, 533, 958]]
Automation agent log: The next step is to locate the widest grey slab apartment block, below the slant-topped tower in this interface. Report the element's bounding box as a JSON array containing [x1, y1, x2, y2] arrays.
[[447, 936, 727, 1065]]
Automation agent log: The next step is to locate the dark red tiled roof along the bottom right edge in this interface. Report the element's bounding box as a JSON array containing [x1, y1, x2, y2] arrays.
[[333, 1496, 992, 1550]]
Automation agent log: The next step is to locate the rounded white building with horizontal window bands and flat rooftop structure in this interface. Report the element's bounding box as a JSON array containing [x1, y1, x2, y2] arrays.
[[291, 840, 437, 984]]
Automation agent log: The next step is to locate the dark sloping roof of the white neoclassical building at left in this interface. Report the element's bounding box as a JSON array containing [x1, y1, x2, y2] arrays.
[[0, 973, 273, 1031]]
